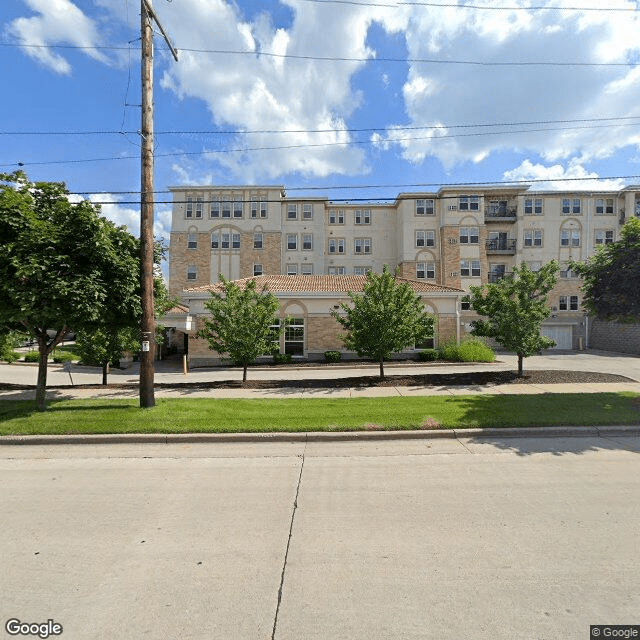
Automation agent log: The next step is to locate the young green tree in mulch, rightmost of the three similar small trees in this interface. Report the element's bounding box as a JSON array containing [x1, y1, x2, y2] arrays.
[[463, 260, 558, 377]]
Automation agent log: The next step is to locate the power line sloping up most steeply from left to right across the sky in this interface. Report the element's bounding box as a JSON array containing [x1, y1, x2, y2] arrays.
[[5, 123, 640, 167]]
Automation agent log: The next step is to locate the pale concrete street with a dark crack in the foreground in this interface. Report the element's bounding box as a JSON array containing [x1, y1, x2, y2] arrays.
[[0, 435, 640, 640]]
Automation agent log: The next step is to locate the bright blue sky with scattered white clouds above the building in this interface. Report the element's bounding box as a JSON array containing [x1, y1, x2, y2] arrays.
[[0, 0, 640, 246]]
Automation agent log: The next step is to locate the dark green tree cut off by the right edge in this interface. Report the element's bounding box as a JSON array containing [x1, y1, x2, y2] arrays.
[[571, 218, 640, 322]]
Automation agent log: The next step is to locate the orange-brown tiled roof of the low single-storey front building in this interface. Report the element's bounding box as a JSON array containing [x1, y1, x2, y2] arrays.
[[184, 275, 464, 293]]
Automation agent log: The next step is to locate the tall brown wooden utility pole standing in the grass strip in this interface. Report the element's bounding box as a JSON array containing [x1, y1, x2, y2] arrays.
[[140, 0, 178, 408]]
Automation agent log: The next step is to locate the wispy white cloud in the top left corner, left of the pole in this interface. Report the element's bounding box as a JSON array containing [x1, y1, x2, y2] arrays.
[[8, 0, 107, 75]]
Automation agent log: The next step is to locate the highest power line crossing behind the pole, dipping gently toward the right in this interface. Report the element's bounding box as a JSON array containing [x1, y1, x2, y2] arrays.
[[0, 42, 640, 67]]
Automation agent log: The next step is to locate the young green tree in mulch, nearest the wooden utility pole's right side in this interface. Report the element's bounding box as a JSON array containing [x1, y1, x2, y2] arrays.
[[198, 274, 287, 382]]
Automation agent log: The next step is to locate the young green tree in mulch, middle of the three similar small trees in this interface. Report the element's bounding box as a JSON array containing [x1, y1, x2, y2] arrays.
[[331, 265, 434, 378]]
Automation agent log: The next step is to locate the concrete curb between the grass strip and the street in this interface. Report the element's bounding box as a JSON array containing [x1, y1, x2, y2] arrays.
[[0, 425, 640, 445]]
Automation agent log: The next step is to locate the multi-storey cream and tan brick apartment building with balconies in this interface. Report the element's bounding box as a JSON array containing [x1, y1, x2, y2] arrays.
[[169, 185, 640, 356]]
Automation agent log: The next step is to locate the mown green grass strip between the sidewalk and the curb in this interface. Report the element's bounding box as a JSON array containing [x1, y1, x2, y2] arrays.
[[0, 392, 640, 435]]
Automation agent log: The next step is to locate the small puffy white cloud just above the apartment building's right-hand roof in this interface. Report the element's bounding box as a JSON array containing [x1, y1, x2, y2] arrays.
[[503, 158, 625, 191]]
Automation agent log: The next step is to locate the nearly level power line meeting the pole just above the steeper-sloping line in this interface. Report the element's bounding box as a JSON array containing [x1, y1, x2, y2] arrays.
[[0, 116, 640, 136]]
